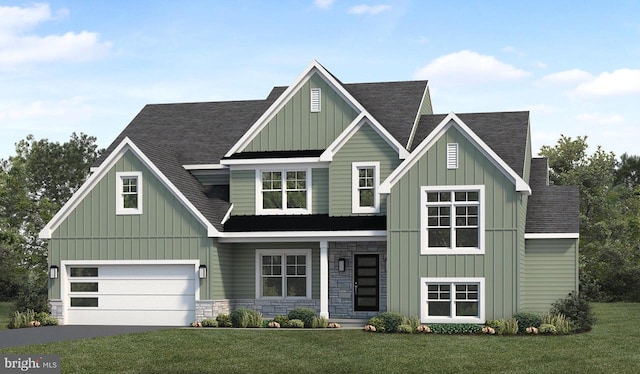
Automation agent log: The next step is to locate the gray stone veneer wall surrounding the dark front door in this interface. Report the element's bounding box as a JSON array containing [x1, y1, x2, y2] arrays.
[[329, 242, 387, 319]]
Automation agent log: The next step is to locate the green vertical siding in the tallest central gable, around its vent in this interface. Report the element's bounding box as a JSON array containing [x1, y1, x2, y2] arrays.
[[242, 74, 358, 152]]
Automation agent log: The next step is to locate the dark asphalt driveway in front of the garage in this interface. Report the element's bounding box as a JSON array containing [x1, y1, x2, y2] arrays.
[[0, 326, 175, 348]]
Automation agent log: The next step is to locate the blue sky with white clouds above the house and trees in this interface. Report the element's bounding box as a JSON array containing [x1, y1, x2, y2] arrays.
[[0, 0, 640, 158]]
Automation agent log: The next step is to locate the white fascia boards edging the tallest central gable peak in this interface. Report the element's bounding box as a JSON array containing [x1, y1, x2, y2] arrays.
[[225, 60, 364, 157]]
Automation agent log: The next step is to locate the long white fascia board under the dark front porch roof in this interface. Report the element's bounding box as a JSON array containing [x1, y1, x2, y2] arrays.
[[218, 230, 387, 243]]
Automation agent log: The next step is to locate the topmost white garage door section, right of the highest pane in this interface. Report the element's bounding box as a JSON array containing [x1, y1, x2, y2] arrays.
[[98, 265, 196, 279]]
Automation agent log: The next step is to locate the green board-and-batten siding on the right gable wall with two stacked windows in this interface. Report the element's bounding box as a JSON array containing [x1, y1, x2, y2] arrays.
[[387, 127, 522, 318]]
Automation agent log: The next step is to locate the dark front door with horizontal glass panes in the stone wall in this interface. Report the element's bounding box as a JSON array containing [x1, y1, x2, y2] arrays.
[[353, 255, 380, 311]]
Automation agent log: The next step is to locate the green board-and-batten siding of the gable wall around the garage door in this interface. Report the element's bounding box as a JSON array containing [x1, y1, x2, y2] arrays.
[[49, 152, 221, 299]]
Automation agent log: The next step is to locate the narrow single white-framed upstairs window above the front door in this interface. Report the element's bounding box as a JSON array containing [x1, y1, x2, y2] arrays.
[[351, 162, 380, 213]]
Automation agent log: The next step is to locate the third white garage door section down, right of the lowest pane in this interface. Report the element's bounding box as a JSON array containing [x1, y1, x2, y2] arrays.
[[98, 294, 195, 311]]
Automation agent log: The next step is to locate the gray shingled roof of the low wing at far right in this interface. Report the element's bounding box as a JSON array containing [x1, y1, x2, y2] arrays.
[[525, 158, 580, 234]]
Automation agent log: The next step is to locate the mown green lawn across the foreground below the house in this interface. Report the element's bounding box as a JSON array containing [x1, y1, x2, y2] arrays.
[[0, 303, 640, 374]]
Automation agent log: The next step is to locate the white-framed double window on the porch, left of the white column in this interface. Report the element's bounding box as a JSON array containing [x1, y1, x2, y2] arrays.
[[256, 250, 311, 298]]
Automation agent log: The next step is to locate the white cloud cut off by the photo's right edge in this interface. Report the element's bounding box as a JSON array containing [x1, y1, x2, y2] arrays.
[[574, 69, 640, 96]]
